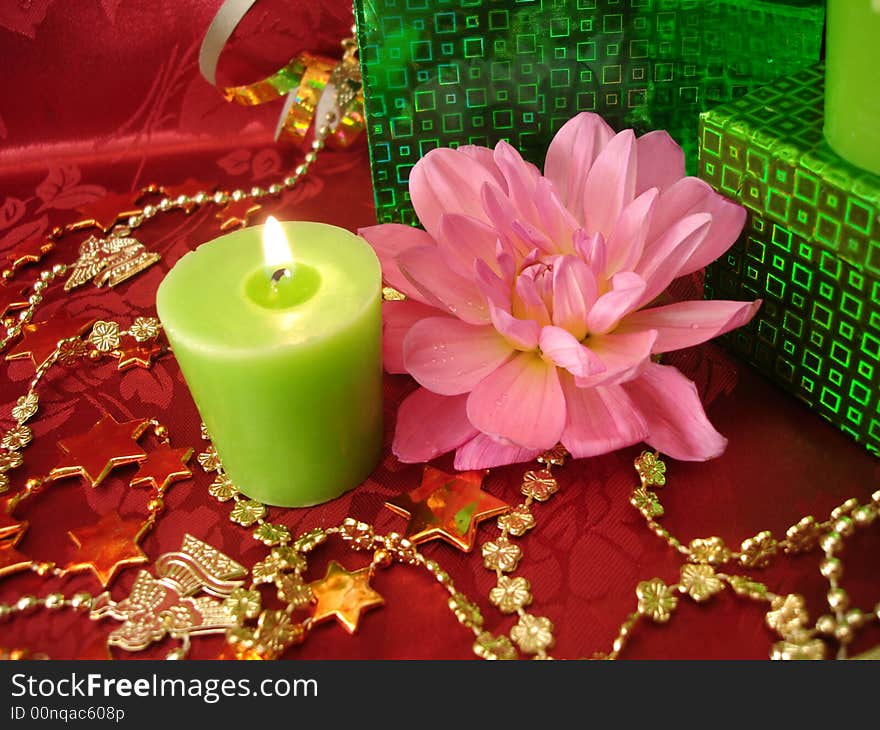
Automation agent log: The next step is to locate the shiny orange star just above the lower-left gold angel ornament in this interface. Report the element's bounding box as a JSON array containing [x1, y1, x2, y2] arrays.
[[64, 510, 148, 588]]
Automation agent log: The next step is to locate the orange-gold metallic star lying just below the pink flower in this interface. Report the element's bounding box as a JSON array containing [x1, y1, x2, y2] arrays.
[[385, 466, 510, 552]]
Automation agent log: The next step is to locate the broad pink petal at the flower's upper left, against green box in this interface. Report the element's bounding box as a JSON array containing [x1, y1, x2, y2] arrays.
[[409, 147, 498, 234]]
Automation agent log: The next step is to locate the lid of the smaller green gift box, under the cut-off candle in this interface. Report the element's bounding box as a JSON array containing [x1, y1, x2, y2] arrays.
[[699, 64, 880, 277]]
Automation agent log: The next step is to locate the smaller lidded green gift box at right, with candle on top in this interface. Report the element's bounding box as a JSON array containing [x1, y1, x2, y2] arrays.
[[699, 66, 880, 453]]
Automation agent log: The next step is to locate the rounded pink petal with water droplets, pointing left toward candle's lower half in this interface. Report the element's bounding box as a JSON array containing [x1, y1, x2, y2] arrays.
[[403, 317, 513, 395]]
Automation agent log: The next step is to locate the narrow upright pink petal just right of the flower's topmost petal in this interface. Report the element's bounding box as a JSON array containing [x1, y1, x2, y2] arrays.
[[584, 129, 637, 240]]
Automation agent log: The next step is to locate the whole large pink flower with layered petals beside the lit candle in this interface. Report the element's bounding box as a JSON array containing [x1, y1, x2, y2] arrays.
[[360, 114, 760, 469]]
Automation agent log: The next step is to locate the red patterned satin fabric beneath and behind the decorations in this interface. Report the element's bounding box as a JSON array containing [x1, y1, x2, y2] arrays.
[[0, 0, 880, 658]]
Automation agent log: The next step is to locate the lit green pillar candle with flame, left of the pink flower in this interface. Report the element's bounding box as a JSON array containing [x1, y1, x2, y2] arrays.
[[156, 220, 382, 507]]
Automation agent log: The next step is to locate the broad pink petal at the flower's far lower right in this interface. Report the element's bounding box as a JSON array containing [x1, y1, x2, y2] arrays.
[[623, 363, 727, 461]]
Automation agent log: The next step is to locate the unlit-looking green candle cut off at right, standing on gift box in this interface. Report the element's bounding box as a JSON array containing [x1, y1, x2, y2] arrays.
[[825, 0, 880, 174]]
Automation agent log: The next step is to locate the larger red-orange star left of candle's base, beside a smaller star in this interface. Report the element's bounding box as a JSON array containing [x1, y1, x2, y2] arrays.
[[49, 414, 150, 487]]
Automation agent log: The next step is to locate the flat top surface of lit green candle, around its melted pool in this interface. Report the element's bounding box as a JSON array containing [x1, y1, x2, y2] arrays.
[[156, 221, 382, 356]]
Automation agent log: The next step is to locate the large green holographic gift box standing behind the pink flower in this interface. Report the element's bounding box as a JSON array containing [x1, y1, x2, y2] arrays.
[[354, 0, 825, 223]]
